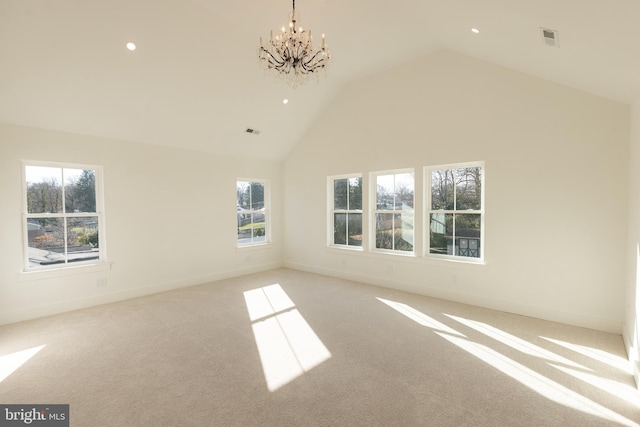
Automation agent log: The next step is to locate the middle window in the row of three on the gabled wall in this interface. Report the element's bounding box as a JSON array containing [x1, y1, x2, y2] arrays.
[[372, 170, 414, 252]]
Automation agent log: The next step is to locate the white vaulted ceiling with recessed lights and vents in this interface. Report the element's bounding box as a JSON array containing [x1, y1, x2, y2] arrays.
[[0, 0, 640, 160]]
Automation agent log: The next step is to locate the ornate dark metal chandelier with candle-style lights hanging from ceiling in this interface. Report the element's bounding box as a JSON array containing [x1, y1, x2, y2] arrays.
[[258, 0, 331, 88]]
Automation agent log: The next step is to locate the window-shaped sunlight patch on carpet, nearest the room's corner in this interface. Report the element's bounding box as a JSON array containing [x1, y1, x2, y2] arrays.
[[244, 284, 331, 391]]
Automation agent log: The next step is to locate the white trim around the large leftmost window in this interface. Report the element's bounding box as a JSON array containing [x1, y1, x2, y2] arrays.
[[20, 160, 110, 278]]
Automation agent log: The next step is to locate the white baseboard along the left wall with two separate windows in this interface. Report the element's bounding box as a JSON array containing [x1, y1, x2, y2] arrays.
[[0, 263, 282, 325]]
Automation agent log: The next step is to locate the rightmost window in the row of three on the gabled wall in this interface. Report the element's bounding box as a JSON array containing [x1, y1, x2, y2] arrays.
[[425, 163, 484, 260]]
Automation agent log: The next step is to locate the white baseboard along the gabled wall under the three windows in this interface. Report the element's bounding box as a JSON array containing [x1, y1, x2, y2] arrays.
[[284, 261, 623, 335]]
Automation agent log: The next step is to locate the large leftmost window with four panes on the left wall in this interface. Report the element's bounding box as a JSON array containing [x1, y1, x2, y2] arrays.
[[22, 162, 105, 270]]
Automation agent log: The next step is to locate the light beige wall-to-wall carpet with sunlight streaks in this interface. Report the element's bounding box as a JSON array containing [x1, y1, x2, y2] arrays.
[[0, 269, 640, 427]]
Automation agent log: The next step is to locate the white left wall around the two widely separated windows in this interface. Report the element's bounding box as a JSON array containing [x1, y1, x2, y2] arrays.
[[0, 125, 282, 324]]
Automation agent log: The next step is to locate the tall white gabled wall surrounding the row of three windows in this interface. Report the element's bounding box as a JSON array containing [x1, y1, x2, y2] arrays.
[[283, 51, 630, 333]]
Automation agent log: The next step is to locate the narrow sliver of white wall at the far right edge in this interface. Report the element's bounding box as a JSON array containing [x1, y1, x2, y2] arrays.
[[623, 103, 640, 385]]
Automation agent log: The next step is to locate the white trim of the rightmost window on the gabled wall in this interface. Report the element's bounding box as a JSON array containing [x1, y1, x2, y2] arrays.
[[422, 161, 486, 264]]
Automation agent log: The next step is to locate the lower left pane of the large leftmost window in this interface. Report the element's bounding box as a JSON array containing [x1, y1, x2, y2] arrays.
[[27, 218, 66, 267]]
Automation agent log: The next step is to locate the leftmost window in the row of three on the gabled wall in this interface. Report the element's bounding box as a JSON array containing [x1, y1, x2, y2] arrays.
[[329, 175, 362, 248]]
